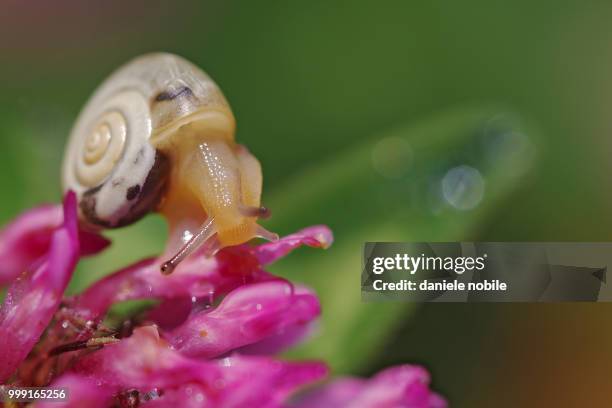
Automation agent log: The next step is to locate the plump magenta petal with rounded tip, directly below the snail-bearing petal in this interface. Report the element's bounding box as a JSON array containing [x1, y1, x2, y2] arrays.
[[165, 280, 321, 358]]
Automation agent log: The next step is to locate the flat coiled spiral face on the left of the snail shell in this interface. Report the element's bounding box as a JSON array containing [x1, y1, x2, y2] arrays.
[[64, 89, 155, 227]]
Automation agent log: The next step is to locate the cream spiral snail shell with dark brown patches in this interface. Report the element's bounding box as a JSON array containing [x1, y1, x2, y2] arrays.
[[62, 53, 235, 228]]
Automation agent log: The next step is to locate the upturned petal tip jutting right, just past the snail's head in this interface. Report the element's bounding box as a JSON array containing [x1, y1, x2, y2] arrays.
[[253, 225, 334, 265]]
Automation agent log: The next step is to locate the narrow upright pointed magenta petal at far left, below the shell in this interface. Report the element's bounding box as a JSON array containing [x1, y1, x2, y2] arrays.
[[0, 193, 79, 382]]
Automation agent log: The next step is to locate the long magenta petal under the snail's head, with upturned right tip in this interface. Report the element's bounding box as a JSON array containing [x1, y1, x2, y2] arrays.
[[72, 226, 333, 319]]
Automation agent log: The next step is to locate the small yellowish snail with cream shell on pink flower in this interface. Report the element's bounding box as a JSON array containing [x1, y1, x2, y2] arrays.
[[62, 53, 278, 273]]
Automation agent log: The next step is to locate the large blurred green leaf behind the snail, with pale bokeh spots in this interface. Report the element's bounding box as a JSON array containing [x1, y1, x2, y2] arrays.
[[264, 108, 535, 373]]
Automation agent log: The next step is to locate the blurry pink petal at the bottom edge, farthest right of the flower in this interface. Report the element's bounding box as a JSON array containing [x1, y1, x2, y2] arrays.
[[297, 365, 447, 408]]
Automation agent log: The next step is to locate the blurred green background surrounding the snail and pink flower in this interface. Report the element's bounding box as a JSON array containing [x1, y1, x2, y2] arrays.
[[0, 0, 612, 407]]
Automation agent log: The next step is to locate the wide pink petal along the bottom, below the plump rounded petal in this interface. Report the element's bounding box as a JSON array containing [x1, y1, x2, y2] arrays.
[[74, 326, 327, 407]]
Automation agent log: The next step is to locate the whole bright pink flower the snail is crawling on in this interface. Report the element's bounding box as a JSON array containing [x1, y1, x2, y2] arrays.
[[0, 193, 445, 408]]
